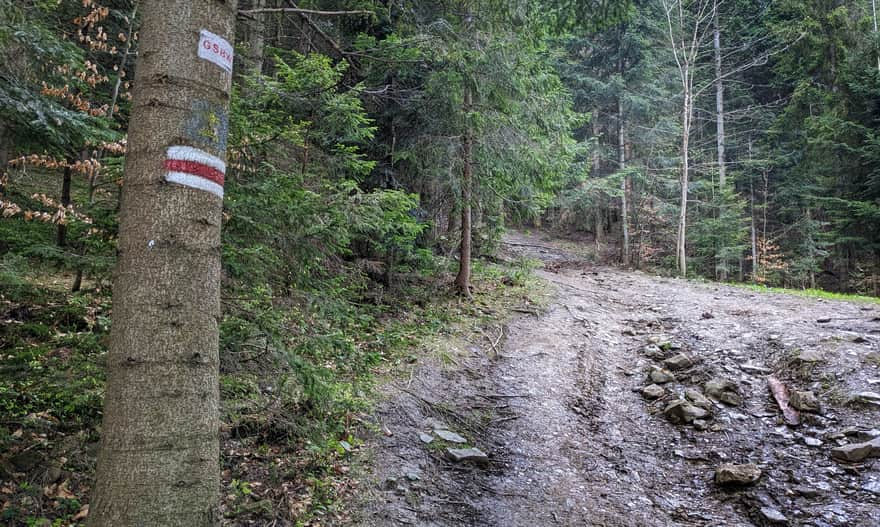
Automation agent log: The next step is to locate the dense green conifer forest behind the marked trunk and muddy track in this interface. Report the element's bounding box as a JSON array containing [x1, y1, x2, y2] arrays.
[[0, 0, 880, 518]]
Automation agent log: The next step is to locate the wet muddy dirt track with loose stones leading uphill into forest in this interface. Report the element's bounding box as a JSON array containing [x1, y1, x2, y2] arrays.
[[358, 234, 880, 527]]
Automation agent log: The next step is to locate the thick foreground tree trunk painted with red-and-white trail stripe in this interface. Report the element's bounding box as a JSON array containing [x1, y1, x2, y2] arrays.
[[88, 0, 236, 527]]
